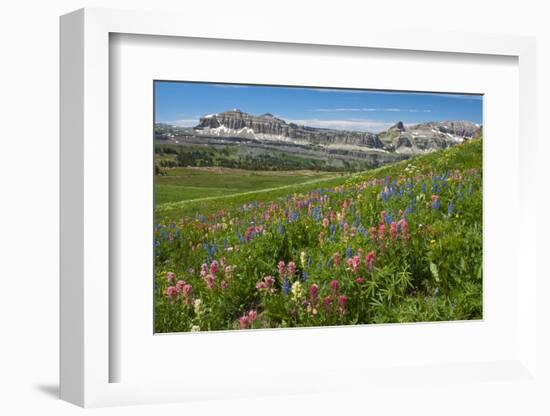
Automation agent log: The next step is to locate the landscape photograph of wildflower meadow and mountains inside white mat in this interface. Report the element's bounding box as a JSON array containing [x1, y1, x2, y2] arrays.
[[152, 80, 483, 333]]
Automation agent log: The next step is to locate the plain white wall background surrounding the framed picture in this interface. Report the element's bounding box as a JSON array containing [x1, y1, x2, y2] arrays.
[[0, 0, 550, 415]]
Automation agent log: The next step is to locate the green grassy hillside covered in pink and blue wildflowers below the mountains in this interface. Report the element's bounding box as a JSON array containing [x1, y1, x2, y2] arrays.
[[155, 139, 482, 332]]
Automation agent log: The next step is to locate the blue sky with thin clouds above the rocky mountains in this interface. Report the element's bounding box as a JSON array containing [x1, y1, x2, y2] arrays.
[[155, 81, 483, 132]]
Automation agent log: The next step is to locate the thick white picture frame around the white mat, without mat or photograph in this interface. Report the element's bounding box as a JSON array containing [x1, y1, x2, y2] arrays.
[[60, 9, 538, 407]]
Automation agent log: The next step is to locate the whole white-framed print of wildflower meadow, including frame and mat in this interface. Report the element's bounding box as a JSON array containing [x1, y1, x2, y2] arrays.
[[61, 9, 541, 410]]
